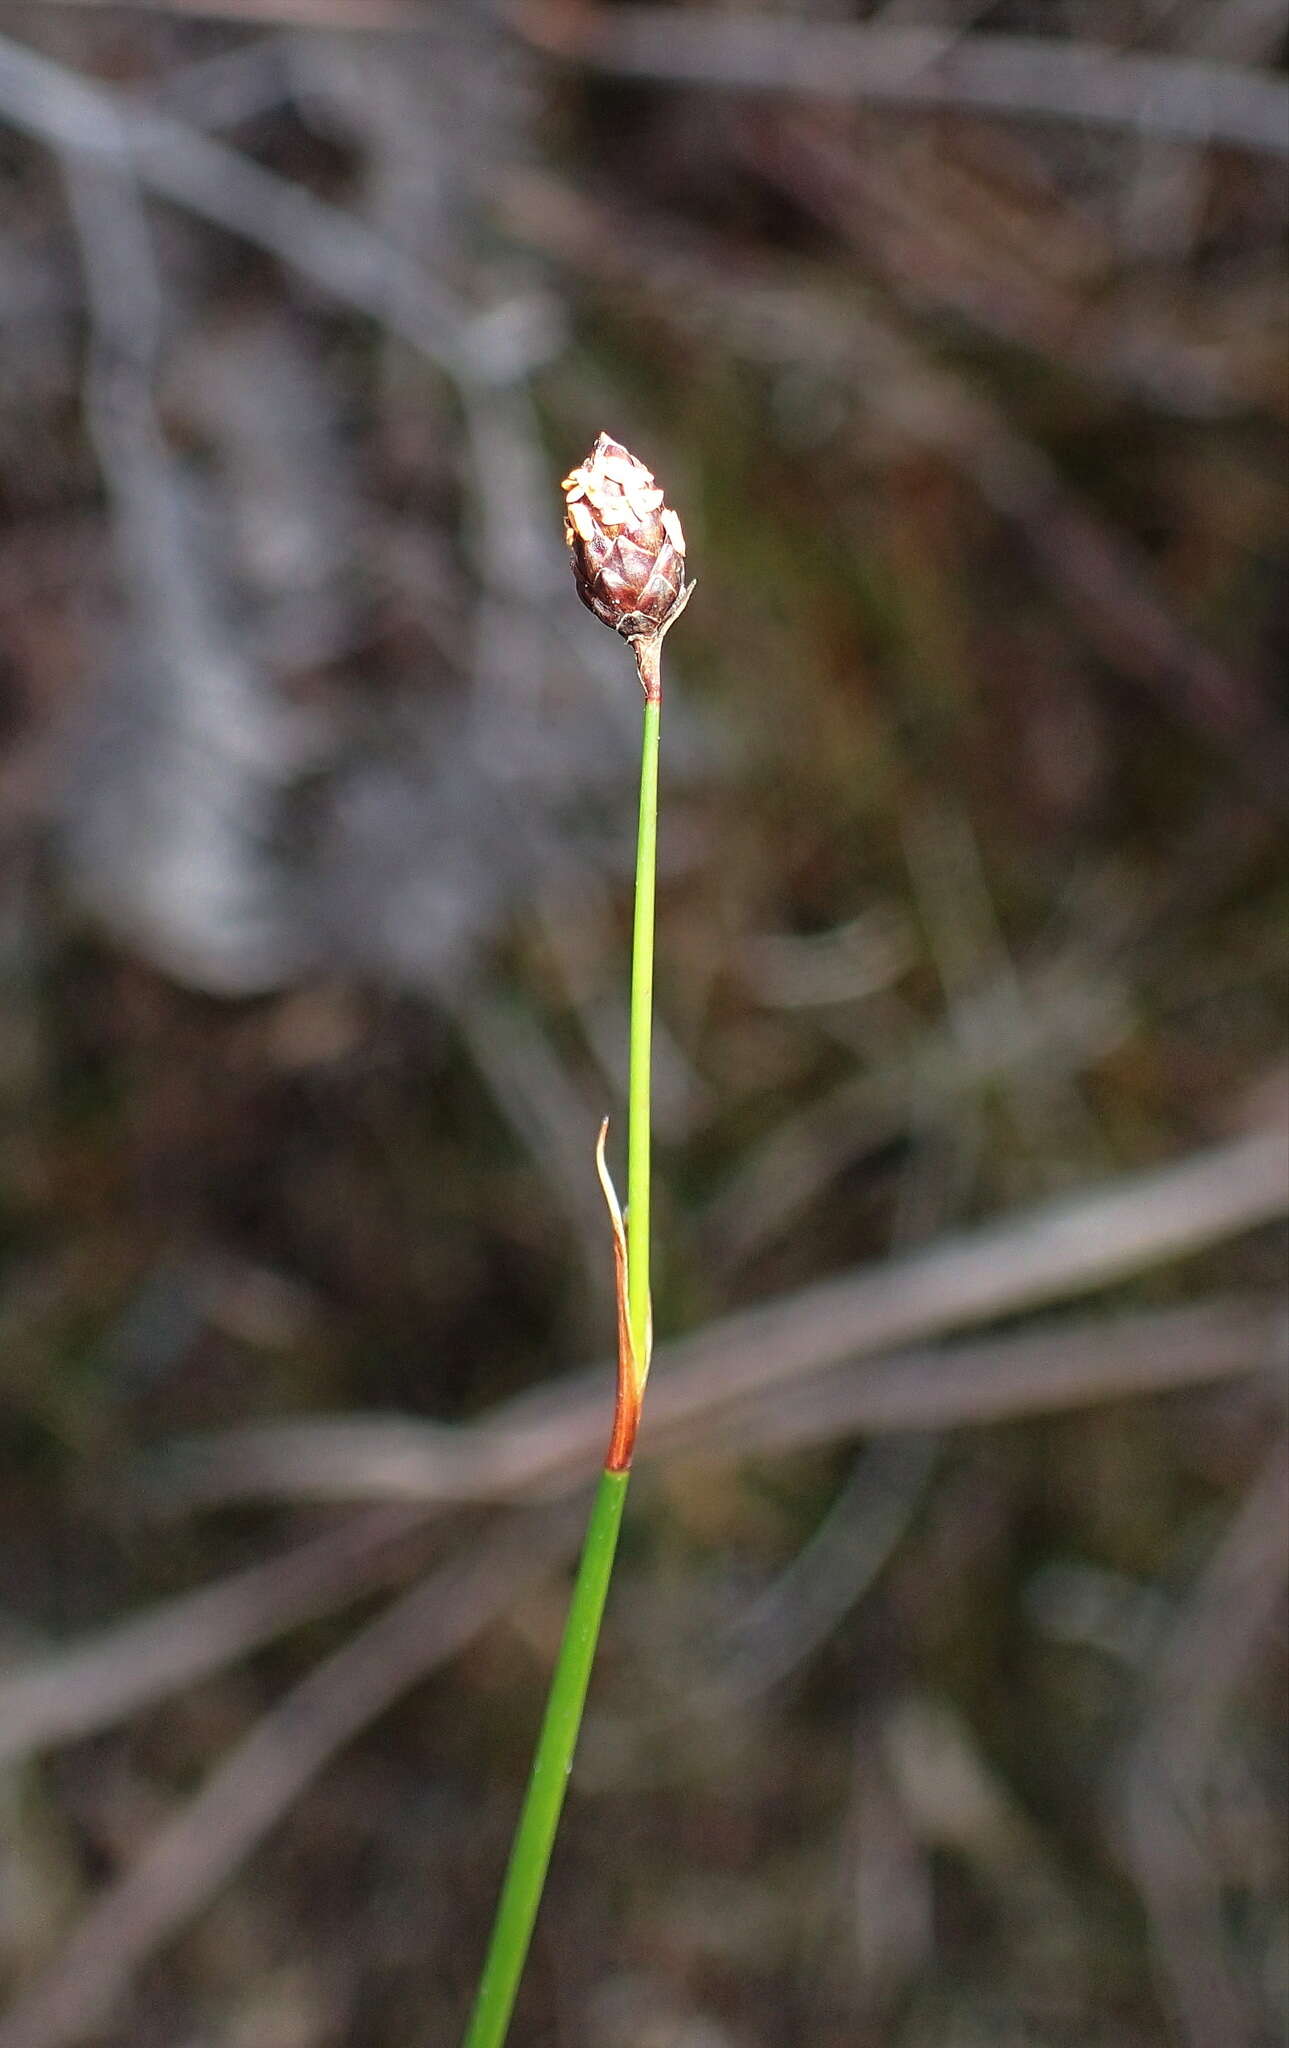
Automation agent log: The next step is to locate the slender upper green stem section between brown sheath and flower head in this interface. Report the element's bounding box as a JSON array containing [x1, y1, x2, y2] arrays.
[[627, 696, 662, 1360]]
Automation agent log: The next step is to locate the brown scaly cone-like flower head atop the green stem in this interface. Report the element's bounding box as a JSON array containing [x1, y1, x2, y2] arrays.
[[564, 434, 689, 641]]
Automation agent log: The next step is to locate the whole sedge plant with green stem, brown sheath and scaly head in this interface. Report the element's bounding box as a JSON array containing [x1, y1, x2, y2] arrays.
[[463, 434, 693, 2048]]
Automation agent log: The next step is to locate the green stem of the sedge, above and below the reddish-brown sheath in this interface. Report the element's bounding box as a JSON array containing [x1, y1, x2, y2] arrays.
[[463, 667, 662, 2048]]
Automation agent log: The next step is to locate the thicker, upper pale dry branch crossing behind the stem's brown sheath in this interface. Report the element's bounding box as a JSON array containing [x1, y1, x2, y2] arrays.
[[152, 1133, 1289, 1507]]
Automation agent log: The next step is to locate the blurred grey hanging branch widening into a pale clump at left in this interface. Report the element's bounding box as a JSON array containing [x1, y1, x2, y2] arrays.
[[64, 147, 309, 995]]
